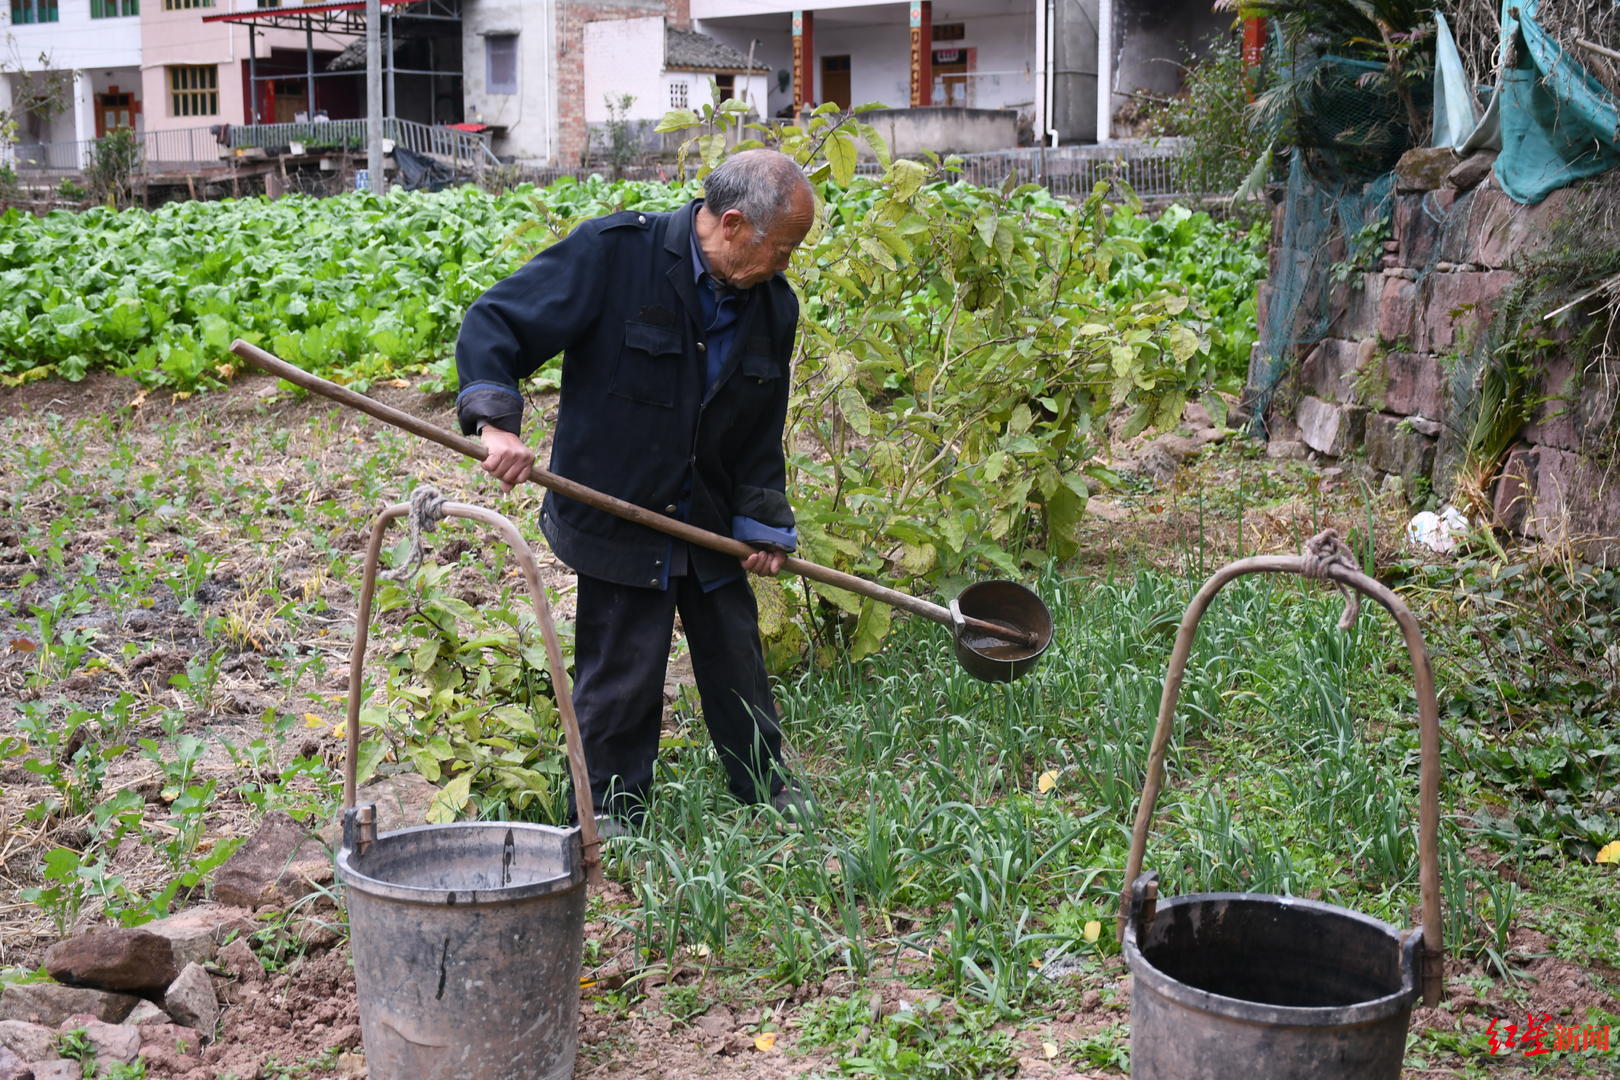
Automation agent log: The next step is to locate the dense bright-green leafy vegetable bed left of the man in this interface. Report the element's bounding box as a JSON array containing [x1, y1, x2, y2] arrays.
[[0, 180, 685, 390]]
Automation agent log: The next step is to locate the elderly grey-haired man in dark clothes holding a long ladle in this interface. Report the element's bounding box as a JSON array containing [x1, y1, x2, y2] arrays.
[[455, 151, 815, 836]]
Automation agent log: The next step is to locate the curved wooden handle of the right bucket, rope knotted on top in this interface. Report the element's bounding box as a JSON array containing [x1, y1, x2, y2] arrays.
[[1115, 529, 1445, 1006]]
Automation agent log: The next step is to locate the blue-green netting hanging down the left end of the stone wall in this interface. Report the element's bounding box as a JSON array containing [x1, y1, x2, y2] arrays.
[[1247, 154, 1395, 434]]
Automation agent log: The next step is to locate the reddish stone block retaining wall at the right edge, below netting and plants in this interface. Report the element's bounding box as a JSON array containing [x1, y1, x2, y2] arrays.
[[1260, 149, 1620, 552]]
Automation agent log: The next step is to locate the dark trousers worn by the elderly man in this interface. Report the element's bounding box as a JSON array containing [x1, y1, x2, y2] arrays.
[[573, 573, 782, 819]]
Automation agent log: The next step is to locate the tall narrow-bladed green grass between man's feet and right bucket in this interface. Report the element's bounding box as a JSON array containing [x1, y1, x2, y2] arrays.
[[609, 573, 1513, 1010]]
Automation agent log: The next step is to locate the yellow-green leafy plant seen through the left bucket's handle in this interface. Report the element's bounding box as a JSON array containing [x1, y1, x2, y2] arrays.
[[360, 567, 567, 823]]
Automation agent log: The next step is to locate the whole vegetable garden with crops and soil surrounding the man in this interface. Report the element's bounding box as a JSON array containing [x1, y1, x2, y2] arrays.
[[0, 149, 1620, 1078]]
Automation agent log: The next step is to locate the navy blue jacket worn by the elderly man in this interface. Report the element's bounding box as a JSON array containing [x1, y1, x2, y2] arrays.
[[455, 202, 799, 588]]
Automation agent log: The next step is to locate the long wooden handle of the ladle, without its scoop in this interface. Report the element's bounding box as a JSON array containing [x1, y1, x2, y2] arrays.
[[230, 338, 1035, 644]]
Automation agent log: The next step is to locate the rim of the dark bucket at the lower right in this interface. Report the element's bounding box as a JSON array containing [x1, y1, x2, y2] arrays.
[[1121, 892, 1422, 1027]]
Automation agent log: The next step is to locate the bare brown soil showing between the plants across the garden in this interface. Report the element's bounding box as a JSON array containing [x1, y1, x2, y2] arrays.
[[0, 376, 1620, 1080]]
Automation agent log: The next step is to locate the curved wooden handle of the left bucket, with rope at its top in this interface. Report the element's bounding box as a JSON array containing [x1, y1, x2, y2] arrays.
[[343, 500, 603, 886]]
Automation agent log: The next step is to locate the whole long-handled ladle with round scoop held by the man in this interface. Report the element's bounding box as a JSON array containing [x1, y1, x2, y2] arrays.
[[230, 338, 1051, 682]]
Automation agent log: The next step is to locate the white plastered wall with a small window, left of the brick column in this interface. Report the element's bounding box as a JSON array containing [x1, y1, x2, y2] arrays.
[[462, 0, 560, 162]]
